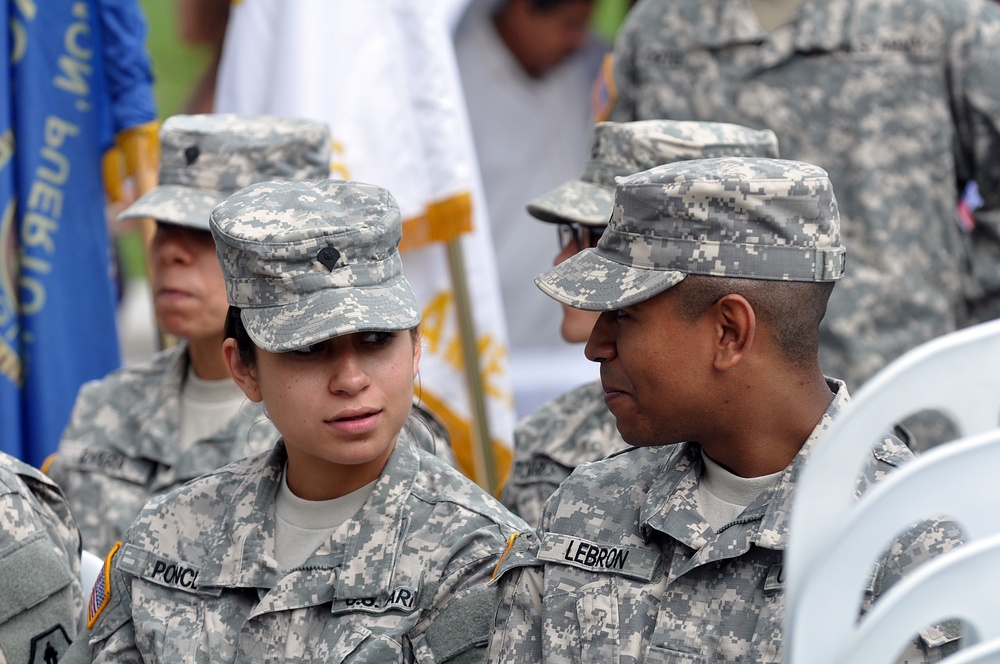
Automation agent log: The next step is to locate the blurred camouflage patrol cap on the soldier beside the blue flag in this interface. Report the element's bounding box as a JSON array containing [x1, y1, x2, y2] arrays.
[[118, 113, 331, 231]]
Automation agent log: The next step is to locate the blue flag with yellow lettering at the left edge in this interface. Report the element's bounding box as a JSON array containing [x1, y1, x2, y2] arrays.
[[0, 0, 155, 466]]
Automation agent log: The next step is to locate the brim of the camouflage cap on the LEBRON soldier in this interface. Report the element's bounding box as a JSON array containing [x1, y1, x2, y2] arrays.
[[535, 249, 687, 311]]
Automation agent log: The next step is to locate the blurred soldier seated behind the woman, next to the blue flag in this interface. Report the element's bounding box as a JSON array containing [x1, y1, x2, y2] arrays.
[[46, 114, 451, 556]]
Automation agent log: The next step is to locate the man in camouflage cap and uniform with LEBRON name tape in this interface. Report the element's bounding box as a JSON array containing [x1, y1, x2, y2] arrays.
[[491, 158, 958, 663]]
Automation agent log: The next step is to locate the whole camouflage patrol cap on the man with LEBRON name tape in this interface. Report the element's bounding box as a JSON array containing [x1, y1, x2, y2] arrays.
[[535, 157, 844, 311]]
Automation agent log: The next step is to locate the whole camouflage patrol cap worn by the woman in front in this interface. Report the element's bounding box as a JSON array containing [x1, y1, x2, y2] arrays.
[[210, 180, 420, 352]]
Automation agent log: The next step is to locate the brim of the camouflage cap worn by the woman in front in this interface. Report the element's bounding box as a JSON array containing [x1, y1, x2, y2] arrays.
[[241, 275, 420, 353]]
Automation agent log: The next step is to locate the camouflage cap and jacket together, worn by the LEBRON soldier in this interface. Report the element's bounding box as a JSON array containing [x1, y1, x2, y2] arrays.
[[490, 158, 960, 663]]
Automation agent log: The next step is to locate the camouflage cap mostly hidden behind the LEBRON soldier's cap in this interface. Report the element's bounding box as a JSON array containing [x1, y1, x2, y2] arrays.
[[527, 120, 778, 226]]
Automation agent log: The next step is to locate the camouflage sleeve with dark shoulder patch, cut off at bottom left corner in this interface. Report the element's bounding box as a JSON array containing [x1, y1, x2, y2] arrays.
[[0, 492, 81, 662]]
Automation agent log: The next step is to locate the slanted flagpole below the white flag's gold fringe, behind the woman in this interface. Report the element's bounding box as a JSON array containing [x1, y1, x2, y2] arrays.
[[446, 236, 499, 494]]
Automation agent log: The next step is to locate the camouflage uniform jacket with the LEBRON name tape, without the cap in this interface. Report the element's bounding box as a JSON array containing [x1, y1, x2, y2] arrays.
[[490, 381, 960, 664]]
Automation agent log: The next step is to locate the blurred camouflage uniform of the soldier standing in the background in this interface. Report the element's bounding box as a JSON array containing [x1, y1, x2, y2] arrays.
[[607, 0, 1000, 389]]
